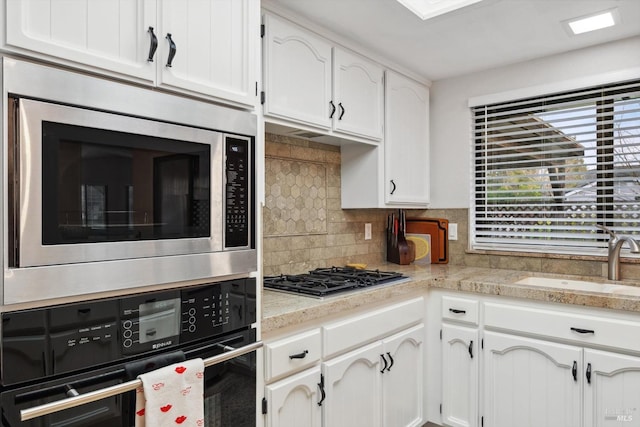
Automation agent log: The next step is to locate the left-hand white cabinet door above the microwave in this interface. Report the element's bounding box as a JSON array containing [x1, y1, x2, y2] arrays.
[[4, 0, 158, 82]]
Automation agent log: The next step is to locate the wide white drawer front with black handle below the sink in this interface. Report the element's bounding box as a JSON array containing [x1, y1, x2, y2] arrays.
[[484, 303, 640, 352]]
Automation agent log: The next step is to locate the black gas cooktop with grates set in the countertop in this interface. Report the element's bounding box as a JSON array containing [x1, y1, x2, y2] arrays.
[[264, 267, 408, 298]]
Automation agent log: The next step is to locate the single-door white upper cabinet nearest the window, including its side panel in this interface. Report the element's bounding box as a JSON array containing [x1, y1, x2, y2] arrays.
[[341, 70, 429, 209]]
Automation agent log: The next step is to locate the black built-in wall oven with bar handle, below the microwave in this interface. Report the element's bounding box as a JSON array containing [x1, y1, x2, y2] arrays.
[[0, 279, 260, 427]]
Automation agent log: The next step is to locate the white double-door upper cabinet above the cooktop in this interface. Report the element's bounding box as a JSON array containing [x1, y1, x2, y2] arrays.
[[264, 14, 384, 140]]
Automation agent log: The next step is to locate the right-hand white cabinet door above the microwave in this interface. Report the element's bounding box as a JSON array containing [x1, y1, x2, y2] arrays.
[[158, 0, 259, 104]]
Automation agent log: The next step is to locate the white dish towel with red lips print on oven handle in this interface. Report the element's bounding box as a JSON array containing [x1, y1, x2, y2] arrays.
[[136, 359, 204, 427]]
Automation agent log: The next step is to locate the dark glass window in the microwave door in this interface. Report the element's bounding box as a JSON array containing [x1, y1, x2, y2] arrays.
[[42, 122, 211, 245]]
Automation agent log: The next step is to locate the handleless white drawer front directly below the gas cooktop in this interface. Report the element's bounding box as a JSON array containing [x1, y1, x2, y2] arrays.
[[322, 298, 424, 357]]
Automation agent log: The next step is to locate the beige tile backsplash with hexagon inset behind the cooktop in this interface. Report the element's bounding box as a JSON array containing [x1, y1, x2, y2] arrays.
[[263, 133, 386, 275]]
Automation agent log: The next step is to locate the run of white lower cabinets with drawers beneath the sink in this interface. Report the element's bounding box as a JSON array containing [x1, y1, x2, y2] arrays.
[[438, 294, 640, 427]]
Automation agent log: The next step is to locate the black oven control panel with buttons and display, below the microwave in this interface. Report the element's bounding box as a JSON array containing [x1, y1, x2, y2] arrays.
[[0, 279, 256, 385]]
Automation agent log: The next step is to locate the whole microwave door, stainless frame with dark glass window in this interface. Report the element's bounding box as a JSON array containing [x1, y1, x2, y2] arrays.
[[10, 99, 225, 267]]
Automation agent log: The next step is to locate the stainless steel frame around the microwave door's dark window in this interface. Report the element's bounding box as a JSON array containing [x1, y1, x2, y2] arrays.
[[19, 99, 224, 267]]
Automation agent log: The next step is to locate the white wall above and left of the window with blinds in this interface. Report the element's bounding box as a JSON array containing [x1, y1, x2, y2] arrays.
[[430, 37, 640, 209]]
